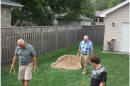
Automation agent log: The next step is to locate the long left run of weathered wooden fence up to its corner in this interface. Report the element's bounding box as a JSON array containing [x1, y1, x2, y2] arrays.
[[1, 26, 82, 65]]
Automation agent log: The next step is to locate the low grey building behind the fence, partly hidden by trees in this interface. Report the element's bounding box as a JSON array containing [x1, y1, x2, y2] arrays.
[[53, 14, 93, 26]]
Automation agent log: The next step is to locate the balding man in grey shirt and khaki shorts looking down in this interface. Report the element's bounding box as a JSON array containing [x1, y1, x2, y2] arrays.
[[11, 39, 37, 86]]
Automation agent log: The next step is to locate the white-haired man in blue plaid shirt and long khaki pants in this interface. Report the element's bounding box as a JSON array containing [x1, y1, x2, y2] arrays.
[[77, 35, 93, 75]]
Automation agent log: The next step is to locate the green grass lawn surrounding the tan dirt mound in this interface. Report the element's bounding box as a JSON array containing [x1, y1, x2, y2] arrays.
[[1, 44, 129, 86]]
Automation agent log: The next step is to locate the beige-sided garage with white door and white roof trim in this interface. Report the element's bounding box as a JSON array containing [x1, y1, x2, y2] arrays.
[[100, 0, 130, 53]]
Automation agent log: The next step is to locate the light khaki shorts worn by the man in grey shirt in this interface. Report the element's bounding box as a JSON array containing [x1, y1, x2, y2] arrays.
[[18, 63, 33, 80]]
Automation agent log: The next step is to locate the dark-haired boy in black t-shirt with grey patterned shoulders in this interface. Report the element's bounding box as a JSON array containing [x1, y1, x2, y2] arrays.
[[90, 55, 107, 86]]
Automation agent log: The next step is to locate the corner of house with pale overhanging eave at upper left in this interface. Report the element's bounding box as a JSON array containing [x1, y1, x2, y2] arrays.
[[1, 0, 23, 27]]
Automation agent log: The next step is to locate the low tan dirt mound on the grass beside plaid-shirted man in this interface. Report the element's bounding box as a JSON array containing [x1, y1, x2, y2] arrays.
[[51, 55, 81, 70]]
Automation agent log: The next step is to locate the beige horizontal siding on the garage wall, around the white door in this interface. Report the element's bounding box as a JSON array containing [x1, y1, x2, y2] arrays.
[[104, 3, 130, 52]]
